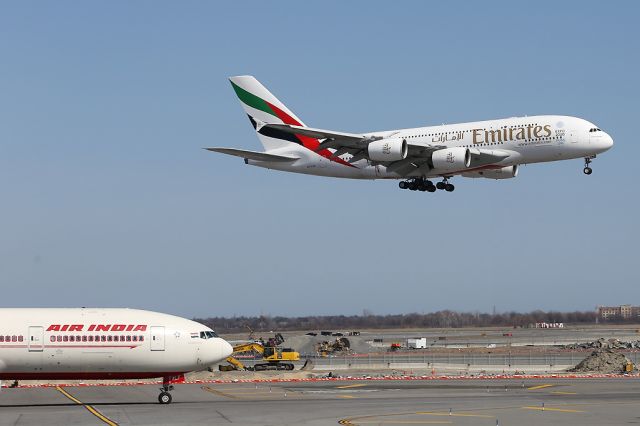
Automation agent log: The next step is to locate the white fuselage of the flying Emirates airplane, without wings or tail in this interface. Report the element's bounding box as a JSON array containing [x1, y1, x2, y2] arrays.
[[246, 115, 613, 179]]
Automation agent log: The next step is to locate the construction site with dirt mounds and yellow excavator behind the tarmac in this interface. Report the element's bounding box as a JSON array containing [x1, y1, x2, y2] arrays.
[[206, 326, 640, 378]]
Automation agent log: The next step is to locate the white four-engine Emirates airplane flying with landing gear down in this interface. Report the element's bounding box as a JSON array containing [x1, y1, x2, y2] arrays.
[[206, 76, 613, 192]]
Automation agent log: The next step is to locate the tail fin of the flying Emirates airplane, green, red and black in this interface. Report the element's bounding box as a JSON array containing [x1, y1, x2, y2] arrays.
[[229, 75, 304, 151]]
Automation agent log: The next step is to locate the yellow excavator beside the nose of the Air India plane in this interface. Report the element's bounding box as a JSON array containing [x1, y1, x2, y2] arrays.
[[218, 333, 300, 371]]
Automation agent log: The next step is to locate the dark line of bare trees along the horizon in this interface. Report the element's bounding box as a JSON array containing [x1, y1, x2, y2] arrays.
[[194, 310, 597, 333]]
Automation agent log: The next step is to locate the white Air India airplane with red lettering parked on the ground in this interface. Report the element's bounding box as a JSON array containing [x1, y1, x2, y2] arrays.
[[0, 308, 233, 404]]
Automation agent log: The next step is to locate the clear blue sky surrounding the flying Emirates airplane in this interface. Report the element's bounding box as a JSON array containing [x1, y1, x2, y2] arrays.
[[0, 1, 640, 317]]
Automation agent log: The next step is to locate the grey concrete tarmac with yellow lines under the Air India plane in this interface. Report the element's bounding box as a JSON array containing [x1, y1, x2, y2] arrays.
[[0, 378, 640, 426]]
